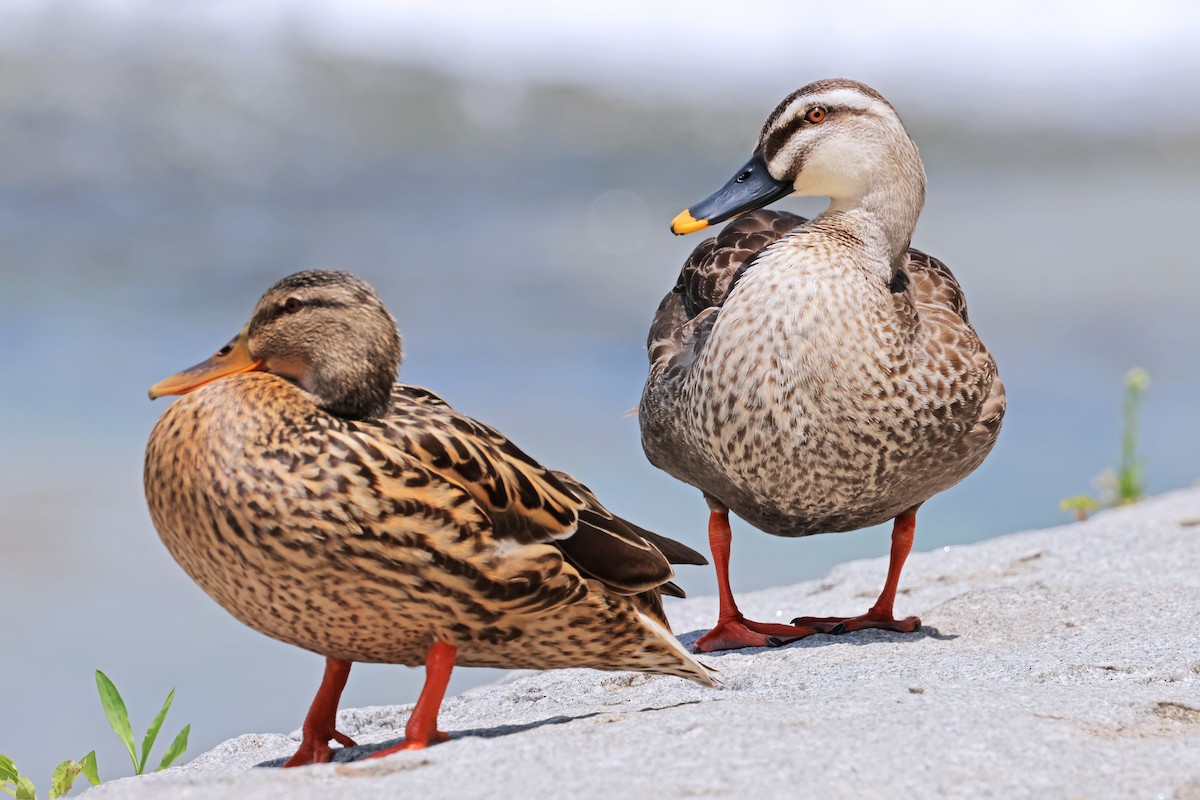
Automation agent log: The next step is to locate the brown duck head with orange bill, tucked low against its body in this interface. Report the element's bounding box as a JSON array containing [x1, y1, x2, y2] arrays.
[[150, 270, 403, 419]]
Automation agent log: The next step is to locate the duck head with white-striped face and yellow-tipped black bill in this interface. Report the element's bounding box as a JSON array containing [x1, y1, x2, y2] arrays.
[[671, 78, 925, 235]]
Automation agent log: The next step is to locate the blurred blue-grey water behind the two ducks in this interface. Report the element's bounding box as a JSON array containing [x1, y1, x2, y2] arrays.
[[0, 0, 1200, 783]]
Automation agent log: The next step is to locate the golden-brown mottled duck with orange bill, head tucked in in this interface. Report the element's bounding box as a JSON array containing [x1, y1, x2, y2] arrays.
[[145, 271, 713, 766]]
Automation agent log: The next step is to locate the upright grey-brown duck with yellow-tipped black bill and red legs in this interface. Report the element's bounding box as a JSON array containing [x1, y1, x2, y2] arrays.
[[638, 79, 1004, 651]]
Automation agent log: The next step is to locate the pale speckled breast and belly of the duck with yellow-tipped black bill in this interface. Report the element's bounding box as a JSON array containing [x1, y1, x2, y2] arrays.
[[685, 283, 973, 536]]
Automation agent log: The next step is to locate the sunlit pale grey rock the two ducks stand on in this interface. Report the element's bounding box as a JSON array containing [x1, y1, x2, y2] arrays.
[[86, 491, 1200, 800]]
